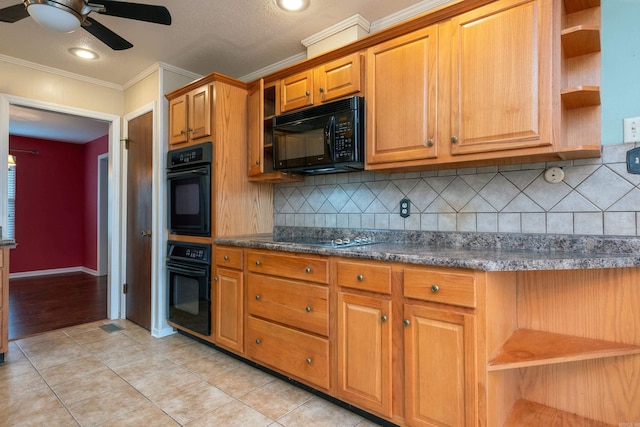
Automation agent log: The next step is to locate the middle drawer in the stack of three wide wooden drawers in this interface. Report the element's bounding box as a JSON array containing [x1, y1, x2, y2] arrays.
[[247, 274, 329, 336]]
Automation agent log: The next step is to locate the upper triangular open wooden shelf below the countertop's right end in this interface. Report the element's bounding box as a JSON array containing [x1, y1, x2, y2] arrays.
[[487, 329, 640, 371]]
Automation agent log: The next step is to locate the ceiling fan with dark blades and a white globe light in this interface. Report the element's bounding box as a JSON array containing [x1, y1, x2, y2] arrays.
[[0, 0, 171, 50]]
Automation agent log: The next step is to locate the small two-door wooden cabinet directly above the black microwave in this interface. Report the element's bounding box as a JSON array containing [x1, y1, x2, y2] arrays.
[[280, 52, 363, 113]]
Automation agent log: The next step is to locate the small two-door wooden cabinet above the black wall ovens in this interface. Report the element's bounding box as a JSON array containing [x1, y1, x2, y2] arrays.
[[169, 85, 211, 145]]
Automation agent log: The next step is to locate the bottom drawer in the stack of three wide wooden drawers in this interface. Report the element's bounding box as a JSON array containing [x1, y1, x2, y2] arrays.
[[246, 317, 329, 390]]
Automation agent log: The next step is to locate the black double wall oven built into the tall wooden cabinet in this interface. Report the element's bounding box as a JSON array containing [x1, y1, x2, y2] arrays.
[[166, 142, 213, 336]]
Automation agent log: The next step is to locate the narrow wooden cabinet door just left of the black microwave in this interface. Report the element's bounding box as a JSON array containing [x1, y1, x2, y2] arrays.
[[247, 79, 264, 176]]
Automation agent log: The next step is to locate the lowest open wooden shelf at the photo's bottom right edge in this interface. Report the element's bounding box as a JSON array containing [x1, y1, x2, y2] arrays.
[[504, 399, 612, 427]]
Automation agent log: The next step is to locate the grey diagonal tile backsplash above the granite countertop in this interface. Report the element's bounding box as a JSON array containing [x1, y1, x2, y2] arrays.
[[274, 144, 640, 236]]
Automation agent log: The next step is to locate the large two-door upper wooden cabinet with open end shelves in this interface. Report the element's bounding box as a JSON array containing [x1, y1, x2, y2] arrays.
[[366, 0, 600, 171]]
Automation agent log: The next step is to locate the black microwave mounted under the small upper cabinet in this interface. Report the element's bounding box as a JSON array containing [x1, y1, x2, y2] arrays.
[[273, 96, 365, 175]]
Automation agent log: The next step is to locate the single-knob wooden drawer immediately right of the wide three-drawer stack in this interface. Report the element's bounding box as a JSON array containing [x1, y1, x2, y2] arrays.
[[338, 262, 391, 294]]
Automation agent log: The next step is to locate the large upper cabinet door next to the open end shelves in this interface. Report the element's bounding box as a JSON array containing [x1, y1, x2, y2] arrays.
[[441, 0, 553, 155]]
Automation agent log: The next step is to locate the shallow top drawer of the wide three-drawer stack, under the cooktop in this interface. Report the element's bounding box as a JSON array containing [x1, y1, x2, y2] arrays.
[[246, 251, 329, 283]]
